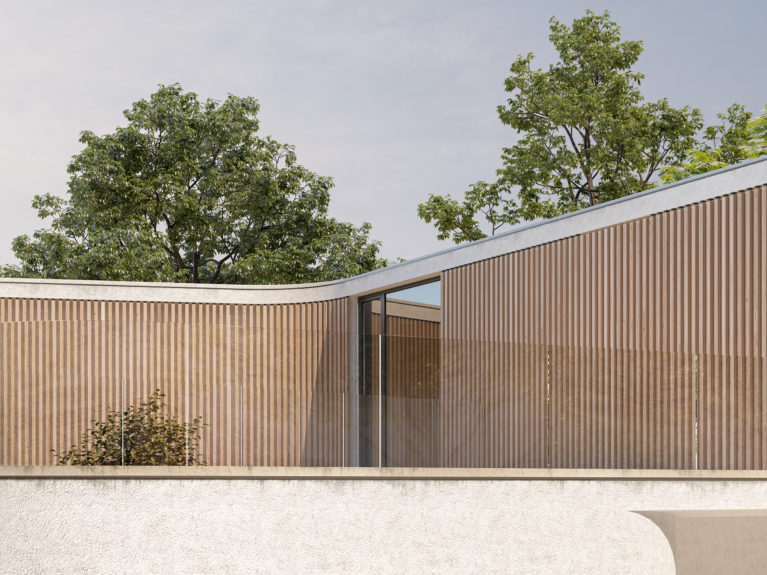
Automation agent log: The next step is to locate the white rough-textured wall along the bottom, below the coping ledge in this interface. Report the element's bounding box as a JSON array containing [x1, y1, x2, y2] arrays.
[[0, 478, 767, 575]]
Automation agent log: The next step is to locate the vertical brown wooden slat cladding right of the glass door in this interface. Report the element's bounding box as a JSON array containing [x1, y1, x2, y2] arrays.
[[441, 187, 767, 469]]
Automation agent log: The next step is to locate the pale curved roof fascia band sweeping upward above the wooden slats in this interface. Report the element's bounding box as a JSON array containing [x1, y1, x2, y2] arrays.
[[0, 156, 767, 304]]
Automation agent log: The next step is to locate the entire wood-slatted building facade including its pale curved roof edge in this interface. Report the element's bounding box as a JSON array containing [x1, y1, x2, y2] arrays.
[[0, 159, 767, 469]]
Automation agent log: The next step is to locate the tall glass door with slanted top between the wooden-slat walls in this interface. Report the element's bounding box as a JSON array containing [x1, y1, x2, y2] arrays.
[[359, 281, 442, 467]]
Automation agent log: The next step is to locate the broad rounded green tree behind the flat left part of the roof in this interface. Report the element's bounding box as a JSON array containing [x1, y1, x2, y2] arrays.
[[0, 85, 387, 284]]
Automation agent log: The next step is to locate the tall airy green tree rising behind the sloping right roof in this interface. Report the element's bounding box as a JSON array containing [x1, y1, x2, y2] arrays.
[[418, 11, 702, 243]]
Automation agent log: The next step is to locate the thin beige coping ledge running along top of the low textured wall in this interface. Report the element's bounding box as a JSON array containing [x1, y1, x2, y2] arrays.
[[0, 465, 767, 481]]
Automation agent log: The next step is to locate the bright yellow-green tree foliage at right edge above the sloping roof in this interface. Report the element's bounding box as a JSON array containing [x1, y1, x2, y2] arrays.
[[660, 104, 767, 182]]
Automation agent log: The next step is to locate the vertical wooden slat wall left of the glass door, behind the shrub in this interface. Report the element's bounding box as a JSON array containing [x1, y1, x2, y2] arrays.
[[0, 299, 349, 466]]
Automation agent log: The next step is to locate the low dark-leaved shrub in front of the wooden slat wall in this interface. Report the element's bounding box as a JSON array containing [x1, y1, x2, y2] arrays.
[[51, 389, 205, 465]]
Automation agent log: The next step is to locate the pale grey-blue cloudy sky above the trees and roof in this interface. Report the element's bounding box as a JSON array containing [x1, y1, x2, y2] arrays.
[[0, 0, 767, 263]]
